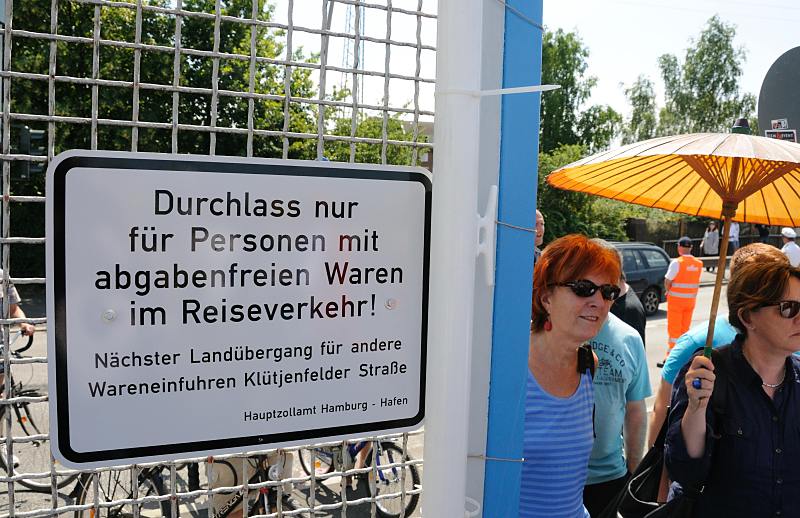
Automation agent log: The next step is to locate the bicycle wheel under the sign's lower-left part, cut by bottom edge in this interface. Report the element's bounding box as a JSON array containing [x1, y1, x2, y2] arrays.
[[74, 467, 177, 518]]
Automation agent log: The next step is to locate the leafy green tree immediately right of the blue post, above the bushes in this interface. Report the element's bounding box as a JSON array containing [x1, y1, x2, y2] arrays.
[[539, 29, 622, 153]]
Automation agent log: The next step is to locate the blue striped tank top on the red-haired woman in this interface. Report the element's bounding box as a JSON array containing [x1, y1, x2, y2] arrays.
[[519, 370, 594, 518]]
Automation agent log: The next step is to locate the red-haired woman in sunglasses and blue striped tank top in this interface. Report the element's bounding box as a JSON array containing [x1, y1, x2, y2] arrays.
[[520, 234, 620, 518]]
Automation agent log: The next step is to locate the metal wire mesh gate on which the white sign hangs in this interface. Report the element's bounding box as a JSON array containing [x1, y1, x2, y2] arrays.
[[0, 0, 437, 517]]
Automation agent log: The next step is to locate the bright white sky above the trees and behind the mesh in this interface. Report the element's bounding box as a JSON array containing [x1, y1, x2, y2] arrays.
[[266, 0, 800, 125]]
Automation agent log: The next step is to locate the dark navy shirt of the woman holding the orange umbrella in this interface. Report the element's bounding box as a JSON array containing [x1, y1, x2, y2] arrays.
[[665, 335, 800, 518]]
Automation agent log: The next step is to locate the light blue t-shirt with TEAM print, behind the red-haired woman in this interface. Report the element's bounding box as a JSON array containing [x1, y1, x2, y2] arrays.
[[586, 313, 651, 484]]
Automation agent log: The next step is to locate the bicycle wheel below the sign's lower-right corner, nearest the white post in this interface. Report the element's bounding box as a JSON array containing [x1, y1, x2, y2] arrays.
[[367, 441, 420, 518]]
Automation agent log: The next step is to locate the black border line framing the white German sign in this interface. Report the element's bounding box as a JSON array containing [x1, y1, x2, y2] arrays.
[[50, 154, 432, 464]]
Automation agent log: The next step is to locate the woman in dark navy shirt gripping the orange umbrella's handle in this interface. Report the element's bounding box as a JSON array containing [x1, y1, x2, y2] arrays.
[[665, 262, 800, 518]]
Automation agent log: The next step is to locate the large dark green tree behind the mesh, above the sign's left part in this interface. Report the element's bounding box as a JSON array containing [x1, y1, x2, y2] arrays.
[[10, 0, 317, 276]]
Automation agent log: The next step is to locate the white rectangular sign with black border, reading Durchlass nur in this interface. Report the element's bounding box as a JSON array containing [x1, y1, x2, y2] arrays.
[[47, 151, 431, 467]]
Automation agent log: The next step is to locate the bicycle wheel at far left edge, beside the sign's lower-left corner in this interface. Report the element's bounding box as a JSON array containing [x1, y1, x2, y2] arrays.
[[0, 398, 78, 493]]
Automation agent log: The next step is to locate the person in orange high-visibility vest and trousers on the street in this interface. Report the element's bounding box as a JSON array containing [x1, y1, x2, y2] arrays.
[[664, 236, 703, 360]]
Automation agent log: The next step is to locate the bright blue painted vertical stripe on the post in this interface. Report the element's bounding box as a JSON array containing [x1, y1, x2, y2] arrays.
[[483, 0, 542, 518]]
